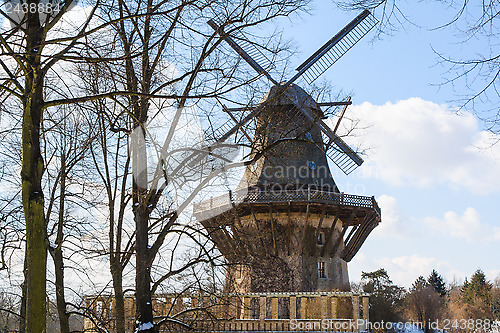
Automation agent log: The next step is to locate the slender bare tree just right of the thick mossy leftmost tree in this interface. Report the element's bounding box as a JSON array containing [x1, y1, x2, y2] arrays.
[[43, 107, 102, 333]]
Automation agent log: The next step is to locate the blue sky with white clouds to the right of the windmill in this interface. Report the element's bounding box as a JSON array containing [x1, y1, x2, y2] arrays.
[[274, 1, 500, 287]]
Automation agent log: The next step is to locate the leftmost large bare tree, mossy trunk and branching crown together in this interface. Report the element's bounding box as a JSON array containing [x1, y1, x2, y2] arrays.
[[0, 0, 189, 332]]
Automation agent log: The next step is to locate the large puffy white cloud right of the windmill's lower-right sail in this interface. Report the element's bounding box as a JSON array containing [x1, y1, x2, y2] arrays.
[[338, 98, 500, 194]]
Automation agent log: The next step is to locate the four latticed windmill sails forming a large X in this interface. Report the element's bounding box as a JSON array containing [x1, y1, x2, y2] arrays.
[[208, 10, 378, 174]]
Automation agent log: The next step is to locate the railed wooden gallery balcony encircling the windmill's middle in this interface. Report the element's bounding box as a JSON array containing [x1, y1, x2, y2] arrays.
[[194, 188, 381, 262]]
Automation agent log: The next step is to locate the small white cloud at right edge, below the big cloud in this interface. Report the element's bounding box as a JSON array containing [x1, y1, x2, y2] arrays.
[[424, 207, 500, 243]]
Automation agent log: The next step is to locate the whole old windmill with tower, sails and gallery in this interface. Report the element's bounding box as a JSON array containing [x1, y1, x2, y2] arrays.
[[195, 11, 380, 292]]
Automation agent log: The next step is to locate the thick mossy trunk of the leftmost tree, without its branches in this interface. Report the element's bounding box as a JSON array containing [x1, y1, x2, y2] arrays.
[[21, 8, 47, 333]]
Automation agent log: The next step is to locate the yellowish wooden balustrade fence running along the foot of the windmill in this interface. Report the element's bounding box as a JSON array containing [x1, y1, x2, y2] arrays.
[[85, 292, 369, 332]]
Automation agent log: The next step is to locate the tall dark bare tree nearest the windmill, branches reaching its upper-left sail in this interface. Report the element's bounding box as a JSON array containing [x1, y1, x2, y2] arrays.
[[78, 0, 310, 332]]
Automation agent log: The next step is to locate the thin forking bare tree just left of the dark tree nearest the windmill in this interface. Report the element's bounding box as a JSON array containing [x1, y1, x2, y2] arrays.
[[78, 60, 135, 333]]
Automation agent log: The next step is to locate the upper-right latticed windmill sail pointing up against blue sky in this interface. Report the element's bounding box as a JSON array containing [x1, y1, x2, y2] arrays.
[[289, 10, 378, 84]]
